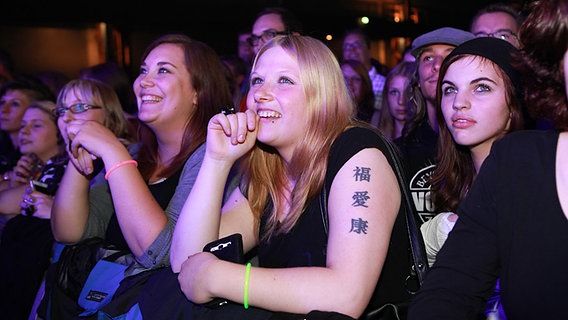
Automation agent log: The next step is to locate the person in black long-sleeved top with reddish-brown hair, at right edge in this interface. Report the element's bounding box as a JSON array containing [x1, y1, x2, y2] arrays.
[[408, 0, 568, 320]]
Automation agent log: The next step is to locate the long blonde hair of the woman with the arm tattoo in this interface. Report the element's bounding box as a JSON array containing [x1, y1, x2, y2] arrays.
[[242, 35, 358, 240]]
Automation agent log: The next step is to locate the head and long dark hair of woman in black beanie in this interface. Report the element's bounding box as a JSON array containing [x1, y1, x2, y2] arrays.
[[430, 38, 524, 231]]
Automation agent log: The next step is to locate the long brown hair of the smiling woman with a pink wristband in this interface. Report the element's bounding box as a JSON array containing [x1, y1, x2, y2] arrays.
[[138, 34, 233, 181]]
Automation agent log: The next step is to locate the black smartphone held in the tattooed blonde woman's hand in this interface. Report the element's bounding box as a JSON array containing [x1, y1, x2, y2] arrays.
[[203, 233, 245, 309]]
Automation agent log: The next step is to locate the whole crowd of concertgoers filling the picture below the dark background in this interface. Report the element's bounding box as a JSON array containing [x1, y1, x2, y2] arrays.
[[0, 0, 568, 320]]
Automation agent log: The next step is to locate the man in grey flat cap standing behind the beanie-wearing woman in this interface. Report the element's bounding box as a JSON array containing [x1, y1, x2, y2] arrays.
[[394, 27, 475, 223]]
